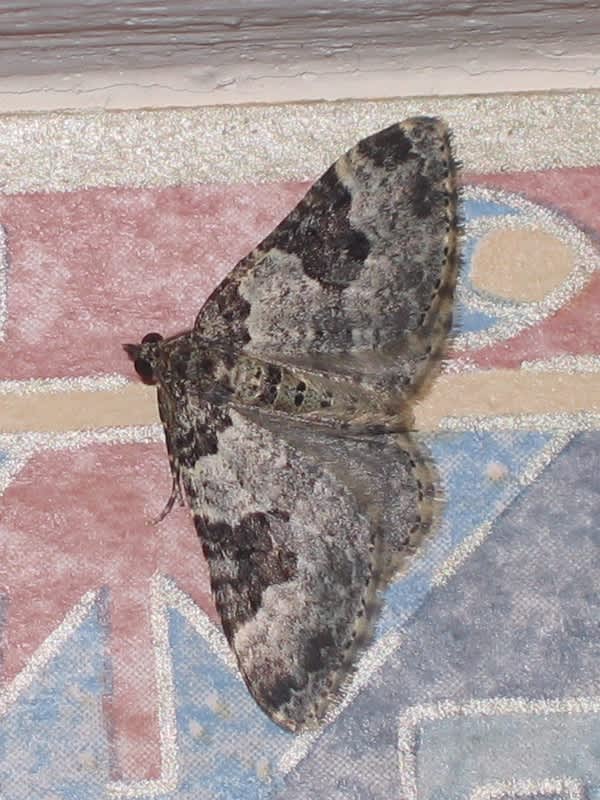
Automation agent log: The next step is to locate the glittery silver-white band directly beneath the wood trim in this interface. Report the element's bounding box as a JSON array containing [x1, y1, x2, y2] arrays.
[[0, 92, 600, 192]]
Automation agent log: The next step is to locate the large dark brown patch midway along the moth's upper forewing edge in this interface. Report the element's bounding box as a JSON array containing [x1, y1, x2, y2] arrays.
[[263, 167, 370, 289]]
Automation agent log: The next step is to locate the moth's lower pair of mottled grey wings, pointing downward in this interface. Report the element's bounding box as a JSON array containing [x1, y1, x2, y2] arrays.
[[180, 400, 433, 731]]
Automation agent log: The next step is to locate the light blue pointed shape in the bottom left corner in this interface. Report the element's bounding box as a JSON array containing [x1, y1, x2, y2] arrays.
[[0, 611, 109, 800]]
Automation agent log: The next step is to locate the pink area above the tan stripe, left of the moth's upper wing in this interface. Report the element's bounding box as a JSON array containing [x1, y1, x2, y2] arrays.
[[0, 183, 306, 380]]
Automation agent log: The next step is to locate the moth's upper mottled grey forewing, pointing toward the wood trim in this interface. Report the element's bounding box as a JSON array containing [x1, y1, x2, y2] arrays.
[[196, 117, 457, 396]]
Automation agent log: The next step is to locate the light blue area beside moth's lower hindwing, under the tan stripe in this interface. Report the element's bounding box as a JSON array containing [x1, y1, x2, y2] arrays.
[[379, 431, 552, 633]]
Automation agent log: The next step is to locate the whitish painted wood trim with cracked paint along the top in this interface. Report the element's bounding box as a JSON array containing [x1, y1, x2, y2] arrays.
[[0, 0, 600, 111]]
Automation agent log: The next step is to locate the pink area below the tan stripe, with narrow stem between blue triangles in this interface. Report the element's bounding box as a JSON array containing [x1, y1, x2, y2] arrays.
[[0, 444, 216, 779]]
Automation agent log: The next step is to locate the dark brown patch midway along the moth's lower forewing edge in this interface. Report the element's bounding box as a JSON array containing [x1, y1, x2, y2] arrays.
[[194, 511, 297, 641]]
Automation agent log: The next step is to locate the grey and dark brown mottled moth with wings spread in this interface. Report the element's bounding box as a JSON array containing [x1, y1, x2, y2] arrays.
[[125, 117, 459, 731]]
